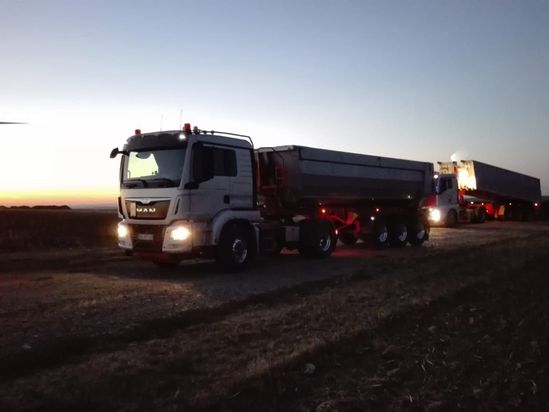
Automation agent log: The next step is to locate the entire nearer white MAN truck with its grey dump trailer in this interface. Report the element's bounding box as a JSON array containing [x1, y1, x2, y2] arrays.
[[111, 124, 433, 271]]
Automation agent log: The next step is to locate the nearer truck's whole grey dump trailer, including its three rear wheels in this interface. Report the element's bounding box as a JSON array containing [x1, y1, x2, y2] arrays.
[[256, 146, 433, 247]]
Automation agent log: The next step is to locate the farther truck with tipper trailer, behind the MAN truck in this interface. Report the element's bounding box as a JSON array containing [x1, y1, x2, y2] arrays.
[[426, 160, 541, 226]]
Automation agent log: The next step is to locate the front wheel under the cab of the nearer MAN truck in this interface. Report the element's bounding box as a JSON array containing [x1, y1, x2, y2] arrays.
[[216, 223, 255, 272]]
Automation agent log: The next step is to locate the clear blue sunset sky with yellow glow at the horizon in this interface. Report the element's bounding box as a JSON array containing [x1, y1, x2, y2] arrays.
[[0, 0, 549, 205]]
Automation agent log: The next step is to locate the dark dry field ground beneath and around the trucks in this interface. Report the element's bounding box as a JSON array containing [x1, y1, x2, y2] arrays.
[[0, 211, 549, 412]]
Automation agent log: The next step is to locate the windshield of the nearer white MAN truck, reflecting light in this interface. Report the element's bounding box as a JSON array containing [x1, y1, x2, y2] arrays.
[[122, 148, 186, 188]]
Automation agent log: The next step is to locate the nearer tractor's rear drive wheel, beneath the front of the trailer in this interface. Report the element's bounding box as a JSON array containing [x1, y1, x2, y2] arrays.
[[298, 220, 337, 258]]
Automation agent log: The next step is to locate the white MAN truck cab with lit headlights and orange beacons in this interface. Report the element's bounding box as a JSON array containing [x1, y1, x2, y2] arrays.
[[111, 124, 260, 267]]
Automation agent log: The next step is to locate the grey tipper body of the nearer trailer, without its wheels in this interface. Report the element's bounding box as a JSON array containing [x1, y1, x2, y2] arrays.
[[256, 146, 433, 214]]
